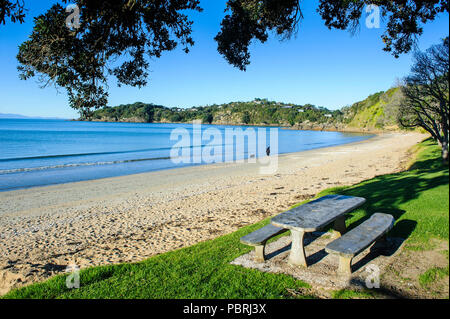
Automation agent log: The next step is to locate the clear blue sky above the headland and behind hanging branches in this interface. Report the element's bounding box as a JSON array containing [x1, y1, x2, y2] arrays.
[[0, 0, 449, 118]]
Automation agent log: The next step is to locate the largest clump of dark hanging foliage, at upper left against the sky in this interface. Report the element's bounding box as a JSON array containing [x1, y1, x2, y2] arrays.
[[17, 0, 201, 117]]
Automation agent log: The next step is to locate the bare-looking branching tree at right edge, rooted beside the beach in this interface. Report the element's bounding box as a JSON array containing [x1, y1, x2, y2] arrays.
[[399, 37, 449, 161]]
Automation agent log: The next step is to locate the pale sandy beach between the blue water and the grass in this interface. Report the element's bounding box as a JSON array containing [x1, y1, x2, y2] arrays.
[[0, 133, 426, 294]]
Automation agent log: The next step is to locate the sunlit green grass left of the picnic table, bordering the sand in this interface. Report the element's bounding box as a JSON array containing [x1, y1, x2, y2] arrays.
[[5, 220, 311, 299]]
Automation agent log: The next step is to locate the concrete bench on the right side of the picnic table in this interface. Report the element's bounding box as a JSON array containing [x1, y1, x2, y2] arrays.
[[325, 213, 394, 275]]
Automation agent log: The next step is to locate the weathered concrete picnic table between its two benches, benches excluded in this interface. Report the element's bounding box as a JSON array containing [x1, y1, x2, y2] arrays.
[[271, 195, 366, 267]]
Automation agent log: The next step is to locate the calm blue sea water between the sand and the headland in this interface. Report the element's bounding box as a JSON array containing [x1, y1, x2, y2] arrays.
[[0, 119, 372, 191]]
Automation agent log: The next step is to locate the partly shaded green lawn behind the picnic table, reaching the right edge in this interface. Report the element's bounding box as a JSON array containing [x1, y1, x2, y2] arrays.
[[319, 140, 449, 250]]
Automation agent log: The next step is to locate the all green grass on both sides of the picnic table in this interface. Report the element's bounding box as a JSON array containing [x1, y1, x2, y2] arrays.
[[4, 140, 449, 299]]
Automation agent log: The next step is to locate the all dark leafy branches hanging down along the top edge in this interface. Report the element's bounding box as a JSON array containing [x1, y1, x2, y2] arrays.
[[4, 0, 449, 118]]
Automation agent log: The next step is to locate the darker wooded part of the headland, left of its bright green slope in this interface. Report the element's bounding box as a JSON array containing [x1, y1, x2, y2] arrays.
[[92, 99, 342, 126]]
